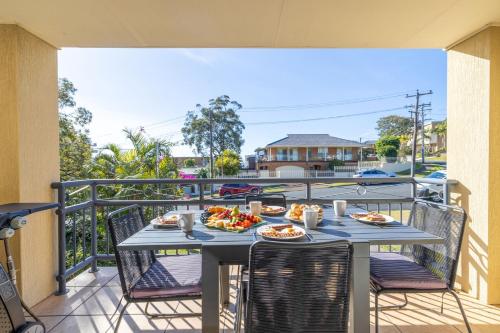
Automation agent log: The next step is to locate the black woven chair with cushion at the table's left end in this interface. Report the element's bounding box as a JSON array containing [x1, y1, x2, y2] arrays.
[[108, 205, 201, 332]]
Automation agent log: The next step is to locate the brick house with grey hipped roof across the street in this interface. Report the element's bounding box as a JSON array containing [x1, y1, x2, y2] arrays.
[[257, 134, 364, 171]]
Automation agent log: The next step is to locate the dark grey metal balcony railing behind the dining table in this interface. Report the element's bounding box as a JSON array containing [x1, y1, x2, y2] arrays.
[[51, 177, 456, 294]]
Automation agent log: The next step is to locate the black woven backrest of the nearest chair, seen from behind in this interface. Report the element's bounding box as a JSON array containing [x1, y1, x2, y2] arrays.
[[245, 240, 352, 333]]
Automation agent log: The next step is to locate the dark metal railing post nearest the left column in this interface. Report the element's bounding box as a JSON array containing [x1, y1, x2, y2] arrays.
[[56, 184, 68, 295]]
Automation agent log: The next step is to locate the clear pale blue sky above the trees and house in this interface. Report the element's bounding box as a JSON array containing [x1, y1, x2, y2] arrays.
[[59, 48, 446, 156]]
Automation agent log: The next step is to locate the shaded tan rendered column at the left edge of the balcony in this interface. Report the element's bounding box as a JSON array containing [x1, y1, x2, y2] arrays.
[[0, 25, 59, 305]]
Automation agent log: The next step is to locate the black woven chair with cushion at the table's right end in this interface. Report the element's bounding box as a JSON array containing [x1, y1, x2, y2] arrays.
[[370, 200, 471, 332]]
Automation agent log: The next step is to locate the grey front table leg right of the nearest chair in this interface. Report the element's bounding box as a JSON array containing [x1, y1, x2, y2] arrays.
[[349, 242, 370, 333]]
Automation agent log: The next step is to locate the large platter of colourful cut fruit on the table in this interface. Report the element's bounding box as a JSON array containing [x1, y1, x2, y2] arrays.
[[201, 206, 266, 232]]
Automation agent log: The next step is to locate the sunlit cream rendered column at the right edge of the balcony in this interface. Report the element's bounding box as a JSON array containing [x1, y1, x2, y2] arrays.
[[447, 27, 500, 304]]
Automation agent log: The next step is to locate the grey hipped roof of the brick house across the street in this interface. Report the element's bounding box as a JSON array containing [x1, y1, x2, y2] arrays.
[[266, 134, 363, 147]]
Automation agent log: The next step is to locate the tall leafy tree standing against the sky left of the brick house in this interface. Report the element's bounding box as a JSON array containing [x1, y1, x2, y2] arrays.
[[182, 95, 245, 156]]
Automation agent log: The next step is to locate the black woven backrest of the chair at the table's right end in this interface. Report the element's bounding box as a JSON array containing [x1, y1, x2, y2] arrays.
[[402, 200, 467, 288]]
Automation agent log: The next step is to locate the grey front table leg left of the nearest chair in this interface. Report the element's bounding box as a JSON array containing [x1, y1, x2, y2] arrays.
[[201, 247, 219, 333]]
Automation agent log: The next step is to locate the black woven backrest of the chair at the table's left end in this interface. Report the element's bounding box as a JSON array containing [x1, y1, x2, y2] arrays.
[[108, 205, 156, 295]]
